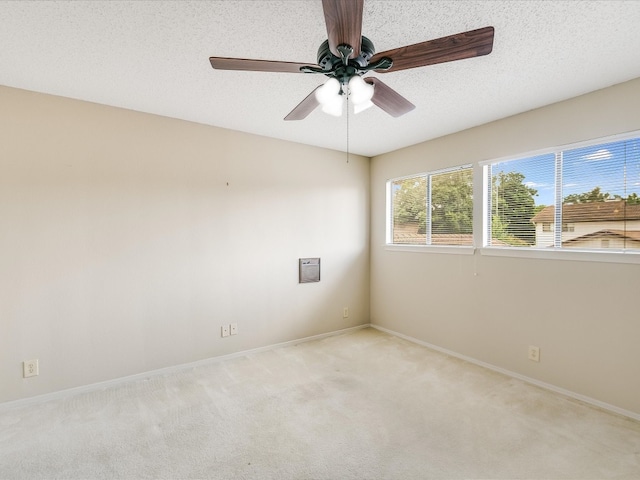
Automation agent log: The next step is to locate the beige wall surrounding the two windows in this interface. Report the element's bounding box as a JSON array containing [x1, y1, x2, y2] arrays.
[[371, 79, 640, 413]]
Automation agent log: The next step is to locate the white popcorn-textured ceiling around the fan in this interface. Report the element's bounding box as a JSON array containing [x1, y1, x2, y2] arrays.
[[0, 0, 640, 156]]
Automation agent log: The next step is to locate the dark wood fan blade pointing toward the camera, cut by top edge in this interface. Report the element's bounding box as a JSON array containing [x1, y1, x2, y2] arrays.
[[322, 0, 364, 58]]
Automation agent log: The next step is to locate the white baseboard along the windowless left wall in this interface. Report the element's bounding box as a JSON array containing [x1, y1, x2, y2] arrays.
[[0, 323, 371, 411]]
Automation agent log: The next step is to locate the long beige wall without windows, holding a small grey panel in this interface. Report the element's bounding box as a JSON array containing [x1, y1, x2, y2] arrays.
[[0, 87, 370, 402]]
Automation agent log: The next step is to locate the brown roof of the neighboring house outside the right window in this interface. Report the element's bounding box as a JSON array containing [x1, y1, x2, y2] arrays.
[[531, 200, 640, 223]]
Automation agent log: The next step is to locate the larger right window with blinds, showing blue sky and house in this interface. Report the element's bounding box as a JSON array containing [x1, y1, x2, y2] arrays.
[[484, 134, 640, 252]]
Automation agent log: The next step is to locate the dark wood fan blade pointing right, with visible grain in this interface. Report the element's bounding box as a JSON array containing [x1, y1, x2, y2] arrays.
[[369, 27, 494, 73]]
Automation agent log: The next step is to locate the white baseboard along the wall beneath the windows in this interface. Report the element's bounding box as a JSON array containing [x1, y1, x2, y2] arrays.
[[371, 324, 640, 421]]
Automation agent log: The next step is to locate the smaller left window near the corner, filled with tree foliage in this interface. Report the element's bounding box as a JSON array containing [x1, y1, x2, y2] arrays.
[[387, 165, 473, 246]]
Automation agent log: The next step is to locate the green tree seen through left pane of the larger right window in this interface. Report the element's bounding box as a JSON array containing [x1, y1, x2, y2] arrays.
[[491, 172, 538, 245]]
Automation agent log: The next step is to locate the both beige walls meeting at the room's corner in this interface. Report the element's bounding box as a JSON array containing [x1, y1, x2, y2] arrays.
[[5, 79, 640, 413]]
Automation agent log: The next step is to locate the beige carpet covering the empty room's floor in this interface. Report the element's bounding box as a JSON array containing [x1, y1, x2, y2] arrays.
[[0, 329, 640, 480]]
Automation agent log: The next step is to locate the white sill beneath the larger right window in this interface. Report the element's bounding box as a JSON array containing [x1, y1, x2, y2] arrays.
[[478, 247, 640, 264]]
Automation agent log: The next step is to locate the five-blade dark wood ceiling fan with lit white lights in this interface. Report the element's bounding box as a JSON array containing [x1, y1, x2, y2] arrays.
[[209, 0, 494, 120]]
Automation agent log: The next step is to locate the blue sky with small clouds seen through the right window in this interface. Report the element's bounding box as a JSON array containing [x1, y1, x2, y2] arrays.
[[492, 138, 640, 205]]
